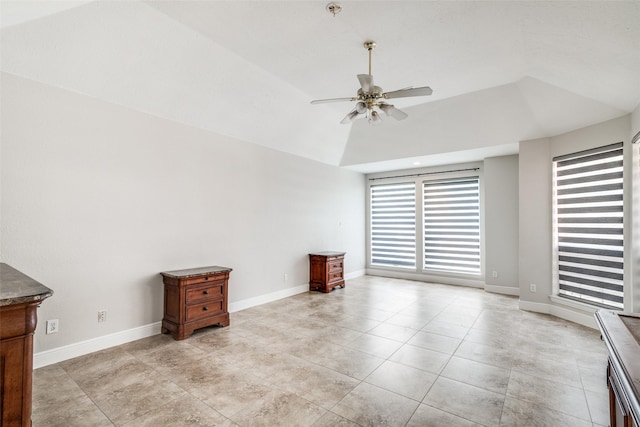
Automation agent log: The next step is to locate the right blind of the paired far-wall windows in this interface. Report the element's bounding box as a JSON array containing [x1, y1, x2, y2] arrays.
[[423, 177, 480, 274]]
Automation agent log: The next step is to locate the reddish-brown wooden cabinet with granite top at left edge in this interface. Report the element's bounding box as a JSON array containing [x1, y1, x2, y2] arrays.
[[0, 263, 53, 427]]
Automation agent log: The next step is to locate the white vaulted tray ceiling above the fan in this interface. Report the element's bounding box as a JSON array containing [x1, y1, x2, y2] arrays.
[[0, 0, 640, 172]]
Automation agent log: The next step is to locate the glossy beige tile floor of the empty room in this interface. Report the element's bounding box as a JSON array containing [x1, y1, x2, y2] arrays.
[[33, 276, 608, 427]]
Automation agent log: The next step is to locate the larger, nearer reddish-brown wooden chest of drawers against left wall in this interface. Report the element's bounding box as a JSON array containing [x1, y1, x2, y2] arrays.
[[160, 266, 231, 340]]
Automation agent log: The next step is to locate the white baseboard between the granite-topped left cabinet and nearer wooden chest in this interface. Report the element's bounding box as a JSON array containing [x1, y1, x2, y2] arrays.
[[33, 322, 161, 369]]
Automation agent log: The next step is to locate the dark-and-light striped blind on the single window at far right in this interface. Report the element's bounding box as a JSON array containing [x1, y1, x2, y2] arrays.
[[554, 143, 624, 309]]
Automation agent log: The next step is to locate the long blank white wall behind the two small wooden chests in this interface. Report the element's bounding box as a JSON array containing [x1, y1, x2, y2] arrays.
[[0, 73, 365, 358]]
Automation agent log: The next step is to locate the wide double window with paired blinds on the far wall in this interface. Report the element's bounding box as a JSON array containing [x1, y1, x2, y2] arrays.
[[369, 167, 482, 276]]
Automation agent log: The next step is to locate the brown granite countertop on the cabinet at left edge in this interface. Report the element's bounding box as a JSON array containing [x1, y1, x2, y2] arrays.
[[0, 263, 53, 306]]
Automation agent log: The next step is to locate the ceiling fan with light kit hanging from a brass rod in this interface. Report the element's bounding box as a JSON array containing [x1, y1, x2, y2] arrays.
[[311, 41, 433, 124]]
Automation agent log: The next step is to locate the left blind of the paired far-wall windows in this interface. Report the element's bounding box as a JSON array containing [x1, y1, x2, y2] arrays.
[[371, 182, 416, 268]]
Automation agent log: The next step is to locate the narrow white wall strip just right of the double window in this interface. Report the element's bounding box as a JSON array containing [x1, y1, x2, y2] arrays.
[[484, 156, 520, 295]]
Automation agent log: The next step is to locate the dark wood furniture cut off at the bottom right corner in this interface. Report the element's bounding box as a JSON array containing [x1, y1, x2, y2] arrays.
[[595, 310, 640, 427]]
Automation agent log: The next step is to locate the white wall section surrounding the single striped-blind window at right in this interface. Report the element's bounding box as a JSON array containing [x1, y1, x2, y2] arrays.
[[519, 115, 633, 325]]
